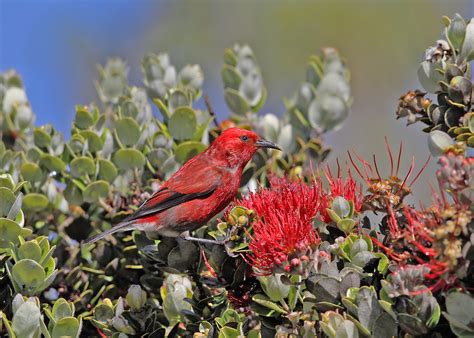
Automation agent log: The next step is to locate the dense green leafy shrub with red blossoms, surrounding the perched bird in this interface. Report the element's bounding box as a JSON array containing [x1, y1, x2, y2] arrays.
[[0, 15, 474, 337]]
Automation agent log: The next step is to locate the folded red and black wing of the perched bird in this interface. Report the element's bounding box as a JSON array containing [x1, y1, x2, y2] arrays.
[[120, 160, 220, 221]]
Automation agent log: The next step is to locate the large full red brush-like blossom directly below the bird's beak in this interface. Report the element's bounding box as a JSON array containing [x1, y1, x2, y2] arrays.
[[236, 177, 320, 274]]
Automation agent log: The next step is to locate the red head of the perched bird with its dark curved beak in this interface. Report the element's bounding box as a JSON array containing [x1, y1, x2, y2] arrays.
[[209, 128, 281, 168]]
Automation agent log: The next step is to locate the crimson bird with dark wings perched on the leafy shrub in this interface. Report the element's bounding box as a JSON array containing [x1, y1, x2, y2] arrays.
[[85, 128, 280, 244]]
